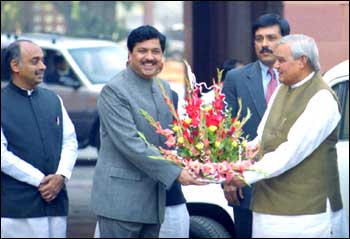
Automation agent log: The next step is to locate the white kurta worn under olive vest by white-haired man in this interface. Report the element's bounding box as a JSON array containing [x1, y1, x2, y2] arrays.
[[243, 72, 349, 237]]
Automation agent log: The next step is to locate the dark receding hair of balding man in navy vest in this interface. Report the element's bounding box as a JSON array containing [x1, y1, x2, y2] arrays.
[[1, 39, 35, 79]]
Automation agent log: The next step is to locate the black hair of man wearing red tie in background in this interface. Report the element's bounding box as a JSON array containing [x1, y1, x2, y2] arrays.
[[252, 13, 290, 37]]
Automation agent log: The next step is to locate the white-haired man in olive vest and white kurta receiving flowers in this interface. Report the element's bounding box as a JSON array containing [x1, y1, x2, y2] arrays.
[[227, 35, 349, 238]]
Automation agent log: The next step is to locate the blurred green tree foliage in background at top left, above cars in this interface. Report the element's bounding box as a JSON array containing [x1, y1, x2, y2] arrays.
[[1, 1, 141, 40]]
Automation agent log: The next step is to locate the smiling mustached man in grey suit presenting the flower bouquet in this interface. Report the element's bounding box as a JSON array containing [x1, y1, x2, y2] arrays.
[[91, 26, 202, 238]]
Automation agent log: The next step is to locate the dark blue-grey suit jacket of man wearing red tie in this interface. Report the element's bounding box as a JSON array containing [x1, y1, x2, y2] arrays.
[[223, 61, 266, 208]]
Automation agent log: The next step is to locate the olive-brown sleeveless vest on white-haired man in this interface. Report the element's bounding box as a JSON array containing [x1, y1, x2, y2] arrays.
[[251, 73, 343, 215]]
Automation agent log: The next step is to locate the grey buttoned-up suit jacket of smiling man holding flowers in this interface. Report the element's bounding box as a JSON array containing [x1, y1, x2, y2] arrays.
[[91, 68, 181, 224]]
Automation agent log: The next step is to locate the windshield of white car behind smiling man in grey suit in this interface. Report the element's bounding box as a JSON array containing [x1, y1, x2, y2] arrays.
[[69, 46, 127, 84]]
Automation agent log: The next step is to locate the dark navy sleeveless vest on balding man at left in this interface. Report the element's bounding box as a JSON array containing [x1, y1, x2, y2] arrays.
[[1, 82, 68, 218]]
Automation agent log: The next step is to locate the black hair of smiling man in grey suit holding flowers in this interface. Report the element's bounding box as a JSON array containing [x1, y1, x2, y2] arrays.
[[127, 25, 166, 52]]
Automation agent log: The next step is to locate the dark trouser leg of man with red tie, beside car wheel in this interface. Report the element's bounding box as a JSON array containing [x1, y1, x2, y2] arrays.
[[233, 207, 253, 238]]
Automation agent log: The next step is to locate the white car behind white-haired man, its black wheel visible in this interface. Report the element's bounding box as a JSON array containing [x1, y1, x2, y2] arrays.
[[182, 60, 349, 238]]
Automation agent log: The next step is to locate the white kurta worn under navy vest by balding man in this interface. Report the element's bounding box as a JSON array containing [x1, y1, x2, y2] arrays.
[[1, 91, 78, 238]]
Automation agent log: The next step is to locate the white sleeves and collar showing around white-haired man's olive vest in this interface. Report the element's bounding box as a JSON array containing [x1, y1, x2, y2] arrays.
[[244, 72, 341, 184]]
